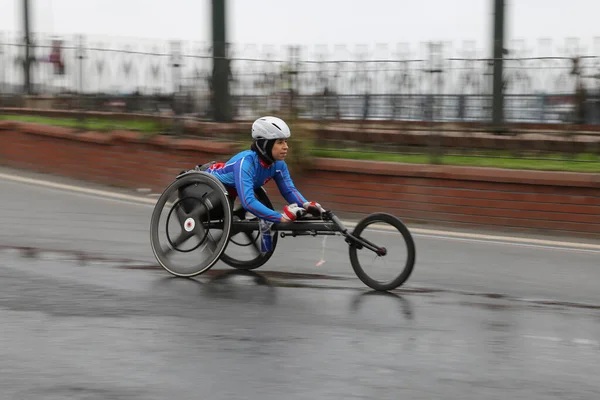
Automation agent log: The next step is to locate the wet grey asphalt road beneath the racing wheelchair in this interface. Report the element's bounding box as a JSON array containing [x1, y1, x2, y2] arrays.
[[0, 169, 600, 399]]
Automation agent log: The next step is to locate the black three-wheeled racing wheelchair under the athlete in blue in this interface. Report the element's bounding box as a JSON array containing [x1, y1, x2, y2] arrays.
[[150, 169, 415, 291]]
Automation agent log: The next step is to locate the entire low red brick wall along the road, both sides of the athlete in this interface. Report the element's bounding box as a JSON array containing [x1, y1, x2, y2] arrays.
[[0, 121, 600, 236]]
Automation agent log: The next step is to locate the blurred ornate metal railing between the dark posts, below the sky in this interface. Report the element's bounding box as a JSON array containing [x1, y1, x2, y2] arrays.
[[0, 33, 600, 124]]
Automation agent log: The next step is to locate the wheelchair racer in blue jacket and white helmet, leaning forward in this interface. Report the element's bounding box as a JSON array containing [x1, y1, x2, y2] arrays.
[[206, 117, 325, 223]]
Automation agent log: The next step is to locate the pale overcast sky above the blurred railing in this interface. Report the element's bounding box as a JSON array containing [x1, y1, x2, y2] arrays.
[[0, 0, 600, 55]]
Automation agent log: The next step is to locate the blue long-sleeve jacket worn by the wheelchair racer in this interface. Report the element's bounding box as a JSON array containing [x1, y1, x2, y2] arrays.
[[206, 150, 306, 222]]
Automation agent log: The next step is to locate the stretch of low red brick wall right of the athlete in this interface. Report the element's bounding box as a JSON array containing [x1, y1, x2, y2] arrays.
[[288, 159, 600, 235]]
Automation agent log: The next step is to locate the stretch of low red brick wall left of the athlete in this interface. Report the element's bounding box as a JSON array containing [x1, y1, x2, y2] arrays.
[[0, 121, 234, 191]]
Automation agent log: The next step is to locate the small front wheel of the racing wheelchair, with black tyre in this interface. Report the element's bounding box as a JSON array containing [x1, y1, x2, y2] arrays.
[[350, 213, 416, 291]]
